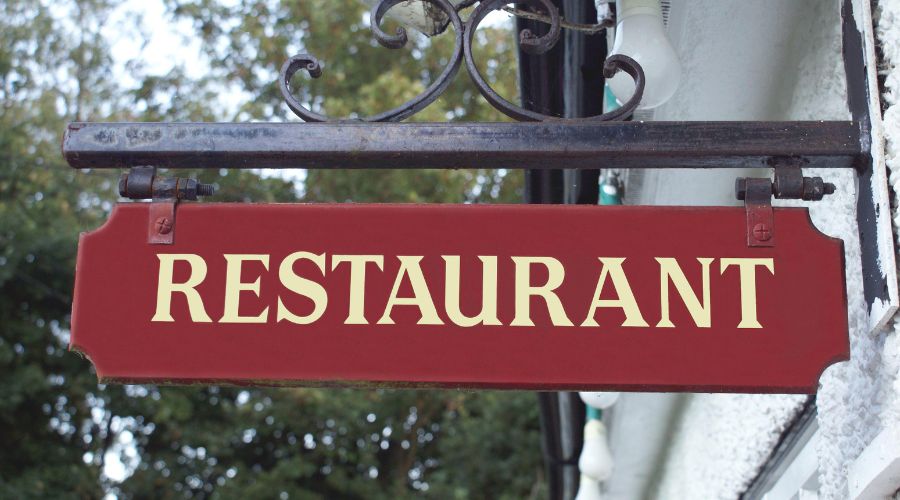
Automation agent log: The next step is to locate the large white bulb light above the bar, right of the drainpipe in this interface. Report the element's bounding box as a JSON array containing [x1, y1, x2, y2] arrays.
[[608, 0, 681, 109]]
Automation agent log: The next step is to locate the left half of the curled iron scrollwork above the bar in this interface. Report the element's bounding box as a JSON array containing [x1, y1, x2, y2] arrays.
[[278, 0, 463, 122]]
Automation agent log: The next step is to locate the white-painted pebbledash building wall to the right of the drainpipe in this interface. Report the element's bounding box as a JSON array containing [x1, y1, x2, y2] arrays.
[[607, 0, 900, 499]]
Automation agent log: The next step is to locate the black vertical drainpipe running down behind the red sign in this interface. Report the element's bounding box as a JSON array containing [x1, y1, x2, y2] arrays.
[[516, 0, 607, 500]]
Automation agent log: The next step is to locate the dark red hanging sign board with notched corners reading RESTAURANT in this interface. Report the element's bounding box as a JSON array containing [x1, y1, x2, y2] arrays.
[[71, 203, 849, 393]]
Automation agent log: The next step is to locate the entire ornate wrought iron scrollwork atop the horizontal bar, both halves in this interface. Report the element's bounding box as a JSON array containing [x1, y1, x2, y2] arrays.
[[279, 0, 644, 122]]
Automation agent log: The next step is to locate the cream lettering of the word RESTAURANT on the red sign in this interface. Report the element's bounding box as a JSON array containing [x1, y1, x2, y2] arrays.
[[151, 251, 775, 329]]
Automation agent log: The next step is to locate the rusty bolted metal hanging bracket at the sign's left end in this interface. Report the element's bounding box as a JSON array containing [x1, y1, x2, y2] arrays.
[[119, 166, 214, 245]]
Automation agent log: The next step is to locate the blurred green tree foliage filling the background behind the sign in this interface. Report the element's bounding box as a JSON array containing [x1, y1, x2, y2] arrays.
[[0, 0, 545, 498]]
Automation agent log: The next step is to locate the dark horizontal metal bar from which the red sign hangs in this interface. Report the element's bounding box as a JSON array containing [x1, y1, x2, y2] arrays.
[[63, 121, 863, 169]]
